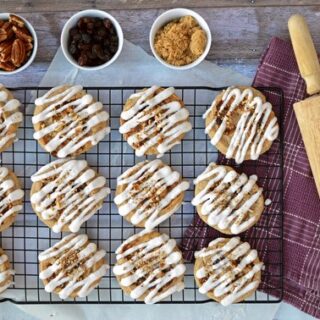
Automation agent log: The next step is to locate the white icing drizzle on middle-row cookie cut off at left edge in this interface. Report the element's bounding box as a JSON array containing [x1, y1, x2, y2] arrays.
[[0, 167, 24, 228]]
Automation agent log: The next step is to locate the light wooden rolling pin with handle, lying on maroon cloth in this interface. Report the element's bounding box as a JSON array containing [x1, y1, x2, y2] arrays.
[[288, 15, 320, 196]]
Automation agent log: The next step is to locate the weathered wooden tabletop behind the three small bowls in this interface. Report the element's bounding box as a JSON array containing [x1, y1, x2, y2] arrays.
[[0, 0, 320, 86]]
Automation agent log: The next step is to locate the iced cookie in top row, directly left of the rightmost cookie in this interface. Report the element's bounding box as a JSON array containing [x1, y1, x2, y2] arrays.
[[119, 86, 192, 157]]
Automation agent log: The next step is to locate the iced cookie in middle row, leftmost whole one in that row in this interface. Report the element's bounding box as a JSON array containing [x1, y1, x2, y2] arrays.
[[30, 159, 110, 232]]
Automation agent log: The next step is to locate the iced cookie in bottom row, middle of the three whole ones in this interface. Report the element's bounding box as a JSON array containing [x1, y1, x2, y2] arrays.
[[113, 230, 186, 304]]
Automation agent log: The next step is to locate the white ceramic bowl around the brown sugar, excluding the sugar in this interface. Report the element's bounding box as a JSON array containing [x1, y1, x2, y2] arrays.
[[149, 8, 211, 70]]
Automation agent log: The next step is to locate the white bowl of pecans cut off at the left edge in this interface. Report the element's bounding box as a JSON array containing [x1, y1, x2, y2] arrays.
[[0, 13, 38, 75]]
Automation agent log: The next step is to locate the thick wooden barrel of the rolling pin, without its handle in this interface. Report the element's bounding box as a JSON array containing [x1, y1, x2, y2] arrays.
[[293, 96, 320, 196]]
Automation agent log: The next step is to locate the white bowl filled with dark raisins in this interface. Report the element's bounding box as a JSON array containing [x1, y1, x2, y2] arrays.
[[61, 9, 123, 70]]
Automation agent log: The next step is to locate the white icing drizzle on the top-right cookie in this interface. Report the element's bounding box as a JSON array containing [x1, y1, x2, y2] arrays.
[[203, 87, 279, 163]]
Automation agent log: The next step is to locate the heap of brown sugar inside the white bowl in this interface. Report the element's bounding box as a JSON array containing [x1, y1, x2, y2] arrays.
[[154, 16, 207, 66]]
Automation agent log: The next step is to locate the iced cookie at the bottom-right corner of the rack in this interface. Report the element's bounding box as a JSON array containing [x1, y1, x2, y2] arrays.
[[194, 237, 263, 306]]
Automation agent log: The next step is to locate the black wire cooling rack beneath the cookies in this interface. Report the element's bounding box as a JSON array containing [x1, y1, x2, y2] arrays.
[[0, 87, 283, 304]]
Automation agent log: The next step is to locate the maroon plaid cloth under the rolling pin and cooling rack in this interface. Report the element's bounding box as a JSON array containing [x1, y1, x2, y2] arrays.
[[181, 38, 320, 318]]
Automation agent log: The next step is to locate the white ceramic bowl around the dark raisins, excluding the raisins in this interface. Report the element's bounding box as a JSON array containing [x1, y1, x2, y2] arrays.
[[61, 9, 123, 71]]
